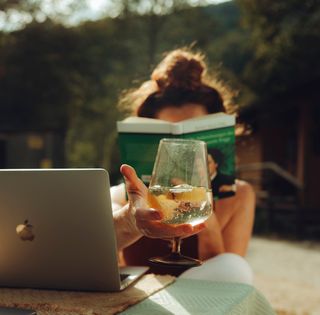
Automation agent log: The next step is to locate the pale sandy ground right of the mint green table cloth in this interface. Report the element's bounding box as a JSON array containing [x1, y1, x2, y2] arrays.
[[246, 237, 320, 315]]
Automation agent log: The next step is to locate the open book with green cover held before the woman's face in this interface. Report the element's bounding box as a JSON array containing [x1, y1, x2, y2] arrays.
[[117, 113, 235, 199]]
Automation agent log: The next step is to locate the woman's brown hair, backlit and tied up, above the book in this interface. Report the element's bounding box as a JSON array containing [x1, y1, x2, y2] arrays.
[[120, 48, 236, 118]]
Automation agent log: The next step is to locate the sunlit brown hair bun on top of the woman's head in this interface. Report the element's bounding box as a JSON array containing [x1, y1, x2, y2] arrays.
[[151, 49, 205, 90]]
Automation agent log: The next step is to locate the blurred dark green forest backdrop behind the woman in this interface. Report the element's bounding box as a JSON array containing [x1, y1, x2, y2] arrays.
[[0, 0, 320, 184]]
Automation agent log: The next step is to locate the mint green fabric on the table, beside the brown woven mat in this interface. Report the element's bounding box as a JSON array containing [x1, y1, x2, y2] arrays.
[[120, 278, 276, 315]]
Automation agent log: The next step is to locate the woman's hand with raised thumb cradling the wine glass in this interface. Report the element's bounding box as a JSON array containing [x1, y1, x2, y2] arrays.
[[120, 164, 205, 239]]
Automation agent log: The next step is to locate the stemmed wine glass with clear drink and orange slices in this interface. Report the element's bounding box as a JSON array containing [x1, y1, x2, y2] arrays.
[[148, 138, 213, 267]]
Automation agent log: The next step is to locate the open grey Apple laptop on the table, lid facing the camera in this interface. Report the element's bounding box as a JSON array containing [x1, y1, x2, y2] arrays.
[[0, 169, 148, 291]]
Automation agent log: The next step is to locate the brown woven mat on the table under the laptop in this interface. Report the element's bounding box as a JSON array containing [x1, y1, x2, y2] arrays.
[[0, 274, 175, 315]]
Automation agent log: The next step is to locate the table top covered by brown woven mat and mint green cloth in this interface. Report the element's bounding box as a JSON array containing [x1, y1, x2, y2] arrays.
[[0, 274, 275, 315]]
